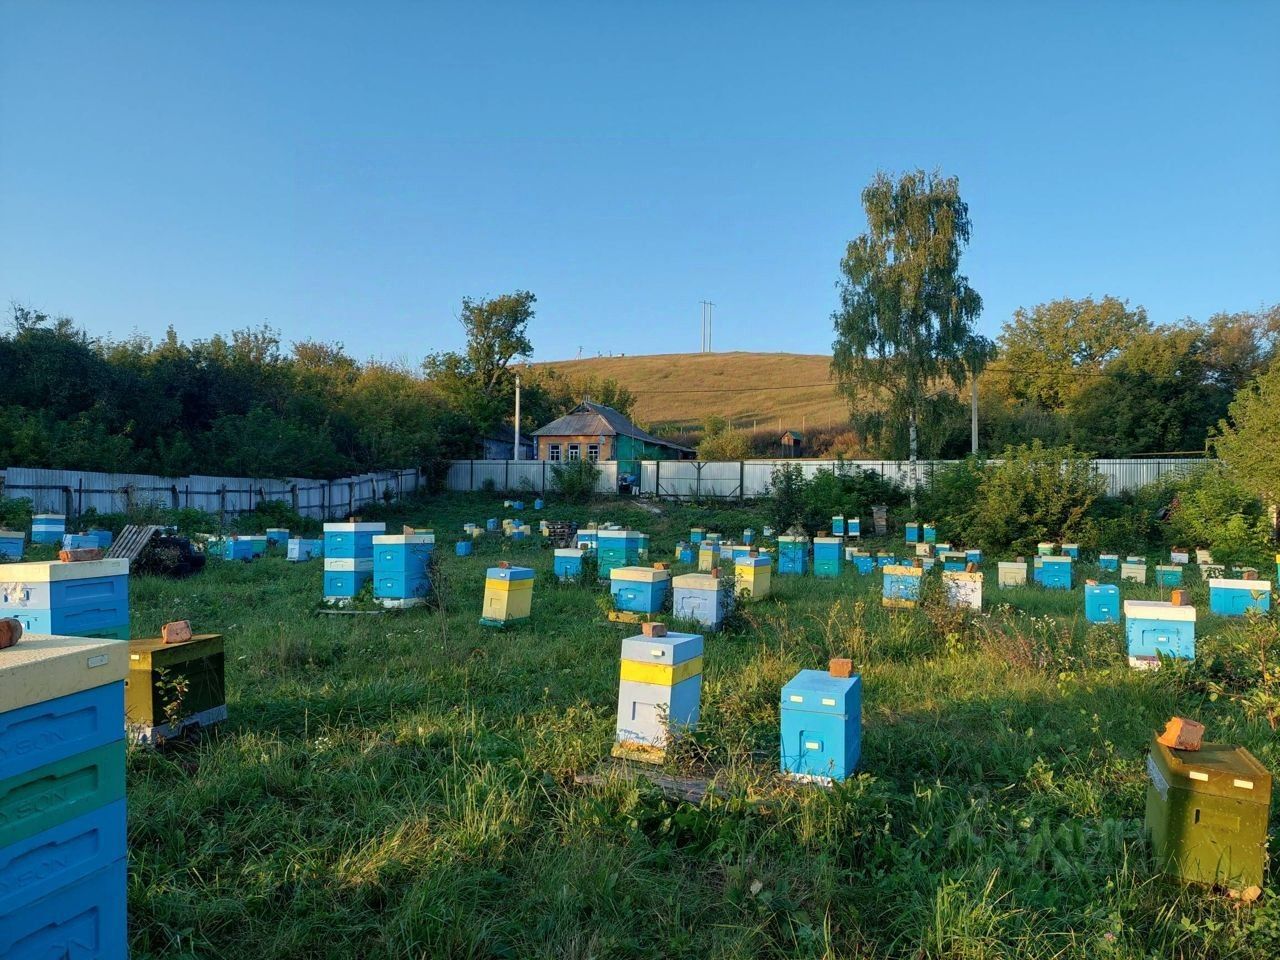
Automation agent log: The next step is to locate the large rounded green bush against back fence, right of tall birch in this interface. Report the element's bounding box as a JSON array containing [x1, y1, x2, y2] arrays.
[[957, 440, 1106, 552]]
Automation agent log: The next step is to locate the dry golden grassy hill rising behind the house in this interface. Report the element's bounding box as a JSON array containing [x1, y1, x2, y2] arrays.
[[535, 352, 847, 430]]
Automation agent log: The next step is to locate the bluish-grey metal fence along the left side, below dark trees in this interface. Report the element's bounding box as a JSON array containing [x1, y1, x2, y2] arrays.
[[0, 467, 422, 520]]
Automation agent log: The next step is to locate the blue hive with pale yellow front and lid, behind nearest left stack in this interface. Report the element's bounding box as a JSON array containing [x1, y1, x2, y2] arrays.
[[0, 559, 129, 640]]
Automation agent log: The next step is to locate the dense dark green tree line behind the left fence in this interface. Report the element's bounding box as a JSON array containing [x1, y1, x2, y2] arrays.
[[0, 300, 634, 477]]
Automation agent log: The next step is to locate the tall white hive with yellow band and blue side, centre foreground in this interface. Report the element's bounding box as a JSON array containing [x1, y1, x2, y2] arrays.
[[613, 634, 703, 763]]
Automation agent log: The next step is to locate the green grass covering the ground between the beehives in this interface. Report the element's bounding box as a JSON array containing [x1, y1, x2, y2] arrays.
[[117, 495, 1280, 960]]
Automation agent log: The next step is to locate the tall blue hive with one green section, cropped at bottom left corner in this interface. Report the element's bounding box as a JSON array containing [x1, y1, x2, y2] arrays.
[[0, 635, 129, 960]]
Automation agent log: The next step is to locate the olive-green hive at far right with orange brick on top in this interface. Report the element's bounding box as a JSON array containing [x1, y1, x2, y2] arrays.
[[1147, 740, 1271, 893]]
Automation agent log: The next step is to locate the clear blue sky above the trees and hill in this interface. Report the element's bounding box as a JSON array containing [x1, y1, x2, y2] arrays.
[[0, 0, 1280, 362]]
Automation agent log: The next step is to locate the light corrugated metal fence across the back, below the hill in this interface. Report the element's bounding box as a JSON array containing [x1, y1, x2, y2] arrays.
[[445, 458, 1201, 499]]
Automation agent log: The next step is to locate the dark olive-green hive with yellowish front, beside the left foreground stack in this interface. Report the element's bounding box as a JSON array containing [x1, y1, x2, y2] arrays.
[[124, 634, 227, 744]]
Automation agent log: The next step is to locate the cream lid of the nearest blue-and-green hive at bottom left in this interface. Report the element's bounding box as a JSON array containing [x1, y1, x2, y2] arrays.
[[0, 634, 129, 713]]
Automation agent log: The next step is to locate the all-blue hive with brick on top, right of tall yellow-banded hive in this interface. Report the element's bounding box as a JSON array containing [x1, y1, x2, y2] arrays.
[[778, 662, 863, 783]]
